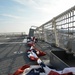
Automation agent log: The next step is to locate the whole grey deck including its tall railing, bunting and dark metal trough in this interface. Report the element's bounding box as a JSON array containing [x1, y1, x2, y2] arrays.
[[0, 6, 75, 75]]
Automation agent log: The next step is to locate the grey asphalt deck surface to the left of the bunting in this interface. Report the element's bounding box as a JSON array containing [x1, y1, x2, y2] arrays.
[[0, 37, 36, 75]]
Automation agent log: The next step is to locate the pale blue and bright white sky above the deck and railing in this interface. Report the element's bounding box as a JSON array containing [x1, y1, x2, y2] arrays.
[[0, 0, 75, 34]]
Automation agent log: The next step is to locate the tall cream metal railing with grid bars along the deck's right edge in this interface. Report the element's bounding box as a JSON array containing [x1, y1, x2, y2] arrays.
[[34, 6, 75, 52]]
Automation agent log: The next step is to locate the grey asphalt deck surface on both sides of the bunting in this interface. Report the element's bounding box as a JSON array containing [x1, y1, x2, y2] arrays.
[[0, 36, 75, 75]]
